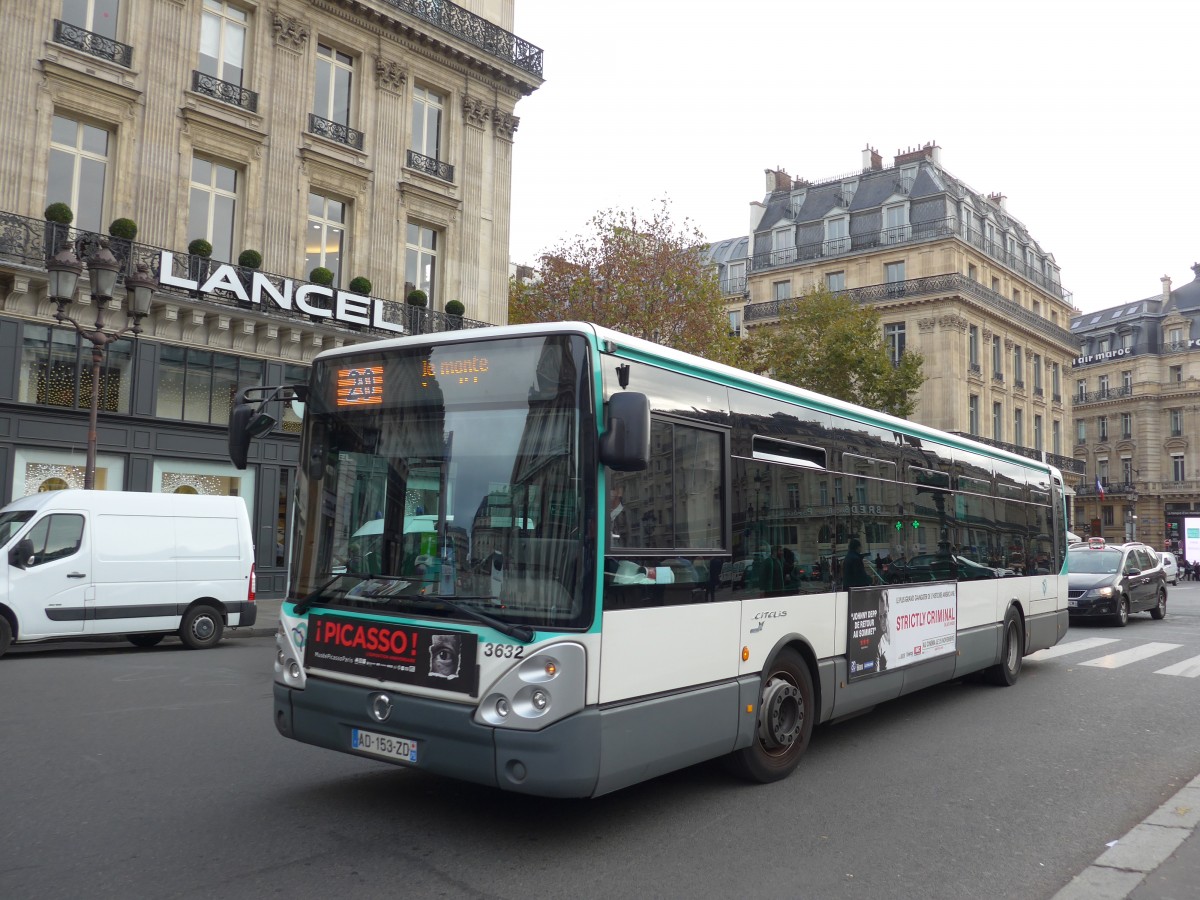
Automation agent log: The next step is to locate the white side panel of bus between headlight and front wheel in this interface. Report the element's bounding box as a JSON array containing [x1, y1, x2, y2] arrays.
[[600, 602, 742, 703]]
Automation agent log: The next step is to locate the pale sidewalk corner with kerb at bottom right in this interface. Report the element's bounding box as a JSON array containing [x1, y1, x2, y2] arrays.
[[1051, 775, 1200, 900]]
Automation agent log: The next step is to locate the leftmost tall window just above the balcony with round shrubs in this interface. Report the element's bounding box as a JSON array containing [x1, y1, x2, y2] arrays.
[[46, 115, 112, 234]]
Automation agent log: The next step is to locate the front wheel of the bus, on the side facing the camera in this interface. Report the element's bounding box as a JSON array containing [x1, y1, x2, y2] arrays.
[[727, 647, 816, 784]]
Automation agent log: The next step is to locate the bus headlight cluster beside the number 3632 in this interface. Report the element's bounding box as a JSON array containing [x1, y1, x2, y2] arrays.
[[475, 643, 587, 731]]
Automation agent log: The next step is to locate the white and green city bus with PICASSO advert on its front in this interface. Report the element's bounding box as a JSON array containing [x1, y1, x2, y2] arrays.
[[229, 323, 1068, 797]]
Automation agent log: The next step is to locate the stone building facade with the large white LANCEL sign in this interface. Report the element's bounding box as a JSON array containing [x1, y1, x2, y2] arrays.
[[0, 0, 542, 596]]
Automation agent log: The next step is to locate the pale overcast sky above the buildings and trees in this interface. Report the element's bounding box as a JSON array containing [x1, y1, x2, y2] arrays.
[[510, 0, 1200, 312]]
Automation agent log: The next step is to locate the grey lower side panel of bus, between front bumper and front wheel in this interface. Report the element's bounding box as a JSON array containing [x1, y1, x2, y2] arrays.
[[595, 682, 740, 794]]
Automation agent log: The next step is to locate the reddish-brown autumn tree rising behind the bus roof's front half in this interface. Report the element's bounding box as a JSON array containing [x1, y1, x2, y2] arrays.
[[509, 199, 740, 362]]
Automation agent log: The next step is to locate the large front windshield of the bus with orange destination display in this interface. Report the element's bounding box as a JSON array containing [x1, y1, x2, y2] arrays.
[[290, 335, 595, 629]]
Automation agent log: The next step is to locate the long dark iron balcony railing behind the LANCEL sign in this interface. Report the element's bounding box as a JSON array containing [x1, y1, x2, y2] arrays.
[[0, 211, 490, 337]]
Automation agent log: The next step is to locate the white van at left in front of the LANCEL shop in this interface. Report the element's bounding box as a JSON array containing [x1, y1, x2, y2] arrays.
[[0, 491, 258, 655]]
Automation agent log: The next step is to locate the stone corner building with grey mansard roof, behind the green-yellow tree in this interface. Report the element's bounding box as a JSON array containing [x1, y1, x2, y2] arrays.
[[710, 144, 1080, 482]]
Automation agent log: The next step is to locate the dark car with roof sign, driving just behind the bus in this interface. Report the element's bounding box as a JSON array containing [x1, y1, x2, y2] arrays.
[[1067, 539, 1166, 625]]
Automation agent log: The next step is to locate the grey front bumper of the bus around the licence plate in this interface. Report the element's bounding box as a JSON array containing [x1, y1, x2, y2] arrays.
[[275, 676, 601, 797]]
